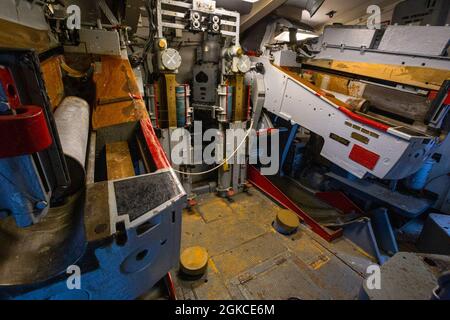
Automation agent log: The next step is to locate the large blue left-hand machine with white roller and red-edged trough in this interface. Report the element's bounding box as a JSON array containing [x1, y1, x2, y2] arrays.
[[0, 50, 186, 299]]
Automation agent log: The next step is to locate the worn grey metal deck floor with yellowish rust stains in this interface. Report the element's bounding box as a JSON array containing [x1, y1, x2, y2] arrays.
[[172, 189, 375, 300]]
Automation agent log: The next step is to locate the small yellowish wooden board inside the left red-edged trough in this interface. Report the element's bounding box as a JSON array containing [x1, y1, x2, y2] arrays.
[[106, 141, 135, 180]]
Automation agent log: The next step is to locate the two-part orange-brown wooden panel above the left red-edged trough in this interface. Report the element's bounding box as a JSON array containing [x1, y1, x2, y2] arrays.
[[92, 56, 149, 130]]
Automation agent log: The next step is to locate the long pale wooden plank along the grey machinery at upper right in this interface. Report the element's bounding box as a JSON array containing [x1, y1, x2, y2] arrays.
[[305, 60, 450, 90]]
